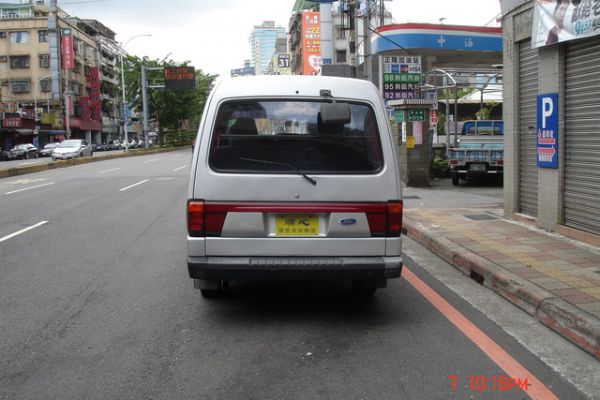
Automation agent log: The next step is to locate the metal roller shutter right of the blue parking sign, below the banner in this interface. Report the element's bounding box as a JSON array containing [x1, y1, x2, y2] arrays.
[[564, 36, 600, 234]]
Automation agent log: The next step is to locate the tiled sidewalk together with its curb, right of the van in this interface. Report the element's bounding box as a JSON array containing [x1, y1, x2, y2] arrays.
[[404, 208, 600, 359]]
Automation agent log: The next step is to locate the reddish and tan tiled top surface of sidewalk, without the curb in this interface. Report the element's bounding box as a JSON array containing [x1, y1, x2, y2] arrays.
[[406, 209, 600, 317]]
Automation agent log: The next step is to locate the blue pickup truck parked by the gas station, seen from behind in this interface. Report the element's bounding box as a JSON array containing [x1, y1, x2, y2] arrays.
[[448, 120, 504, 185]]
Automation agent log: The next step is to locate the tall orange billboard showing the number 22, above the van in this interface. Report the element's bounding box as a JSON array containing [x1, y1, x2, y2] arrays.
[[302, 11, 321, 75]]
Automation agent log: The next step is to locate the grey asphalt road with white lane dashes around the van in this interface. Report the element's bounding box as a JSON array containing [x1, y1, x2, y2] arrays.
[[0, 149, 597, 399]]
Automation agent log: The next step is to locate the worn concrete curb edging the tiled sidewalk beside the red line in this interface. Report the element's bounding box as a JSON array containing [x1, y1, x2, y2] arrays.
[[403, 216, 600, 359]]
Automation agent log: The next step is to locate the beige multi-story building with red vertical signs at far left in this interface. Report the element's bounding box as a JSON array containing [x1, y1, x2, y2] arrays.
[[0, 1, 118, 148]]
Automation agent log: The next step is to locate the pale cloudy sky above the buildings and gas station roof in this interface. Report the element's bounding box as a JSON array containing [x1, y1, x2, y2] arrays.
[[58, 0, 500, 76]]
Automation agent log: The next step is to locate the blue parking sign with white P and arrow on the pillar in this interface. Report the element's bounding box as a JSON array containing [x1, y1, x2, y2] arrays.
[[536, 93, 558, 168]]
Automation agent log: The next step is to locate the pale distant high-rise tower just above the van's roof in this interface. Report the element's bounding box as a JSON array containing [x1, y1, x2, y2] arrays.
[[249, 21, 285, 75]]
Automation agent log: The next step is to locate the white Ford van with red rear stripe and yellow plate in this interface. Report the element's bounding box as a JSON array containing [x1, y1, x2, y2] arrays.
[[187, 75, 402, 297]]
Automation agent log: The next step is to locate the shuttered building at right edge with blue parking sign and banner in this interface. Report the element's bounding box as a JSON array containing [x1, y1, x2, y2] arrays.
[[501, 0, 600, 241]]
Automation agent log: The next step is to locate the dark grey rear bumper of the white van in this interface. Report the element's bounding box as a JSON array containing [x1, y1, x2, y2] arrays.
[[187, 256, 402, 280]]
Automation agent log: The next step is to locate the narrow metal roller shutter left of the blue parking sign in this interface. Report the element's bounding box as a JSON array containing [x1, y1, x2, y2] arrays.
[[519, 40, 538, 217]]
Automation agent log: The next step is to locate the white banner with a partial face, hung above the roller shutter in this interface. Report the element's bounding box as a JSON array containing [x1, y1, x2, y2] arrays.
[[531, 0, 600, 48]]
